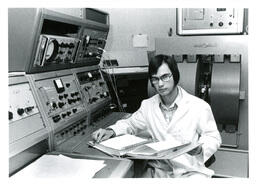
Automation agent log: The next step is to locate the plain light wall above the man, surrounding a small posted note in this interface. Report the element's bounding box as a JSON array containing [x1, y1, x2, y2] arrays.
[[102, 8, 176, 66]]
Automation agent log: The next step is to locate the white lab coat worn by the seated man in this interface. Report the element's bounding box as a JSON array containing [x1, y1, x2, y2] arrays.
[[109, 86, 221, 177]]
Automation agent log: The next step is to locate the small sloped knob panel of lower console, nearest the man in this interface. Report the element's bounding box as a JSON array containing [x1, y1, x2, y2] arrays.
[[76, 69, 110, 110]]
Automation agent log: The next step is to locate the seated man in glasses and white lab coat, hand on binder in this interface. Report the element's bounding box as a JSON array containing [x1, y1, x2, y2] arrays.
[[92, 55, 221, 178]]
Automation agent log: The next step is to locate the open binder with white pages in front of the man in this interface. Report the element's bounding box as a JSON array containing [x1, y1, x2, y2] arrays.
[[88, 134, 202, 159]]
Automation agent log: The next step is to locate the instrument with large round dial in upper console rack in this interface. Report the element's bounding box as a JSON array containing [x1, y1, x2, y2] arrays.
[[34, 35, 80, 67]]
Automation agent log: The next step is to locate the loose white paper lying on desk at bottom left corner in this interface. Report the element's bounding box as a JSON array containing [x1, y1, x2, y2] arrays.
[[10, 155, 106, 179]]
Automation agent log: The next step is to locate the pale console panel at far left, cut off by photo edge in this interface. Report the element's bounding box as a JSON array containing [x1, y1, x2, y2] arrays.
[[8, 75, 48, 157]]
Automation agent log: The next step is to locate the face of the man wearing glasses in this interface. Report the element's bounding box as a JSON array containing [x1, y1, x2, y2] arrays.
[[151, 63, 175, 96]]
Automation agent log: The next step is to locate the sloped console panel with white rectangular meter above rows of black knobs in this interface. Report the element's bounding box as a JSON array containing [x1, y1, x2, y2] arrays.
[[34, 73, 85, 129]]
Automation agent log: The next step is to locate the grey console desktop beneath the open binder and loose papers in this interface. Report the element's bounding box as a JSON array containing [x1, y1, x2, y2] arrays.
[[51, 113, 134, 178]]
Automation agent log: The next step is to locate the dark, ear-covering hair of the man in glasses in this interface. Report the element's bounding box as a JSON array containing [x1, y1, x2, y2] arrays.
[[148, 54, 180, 86]]
